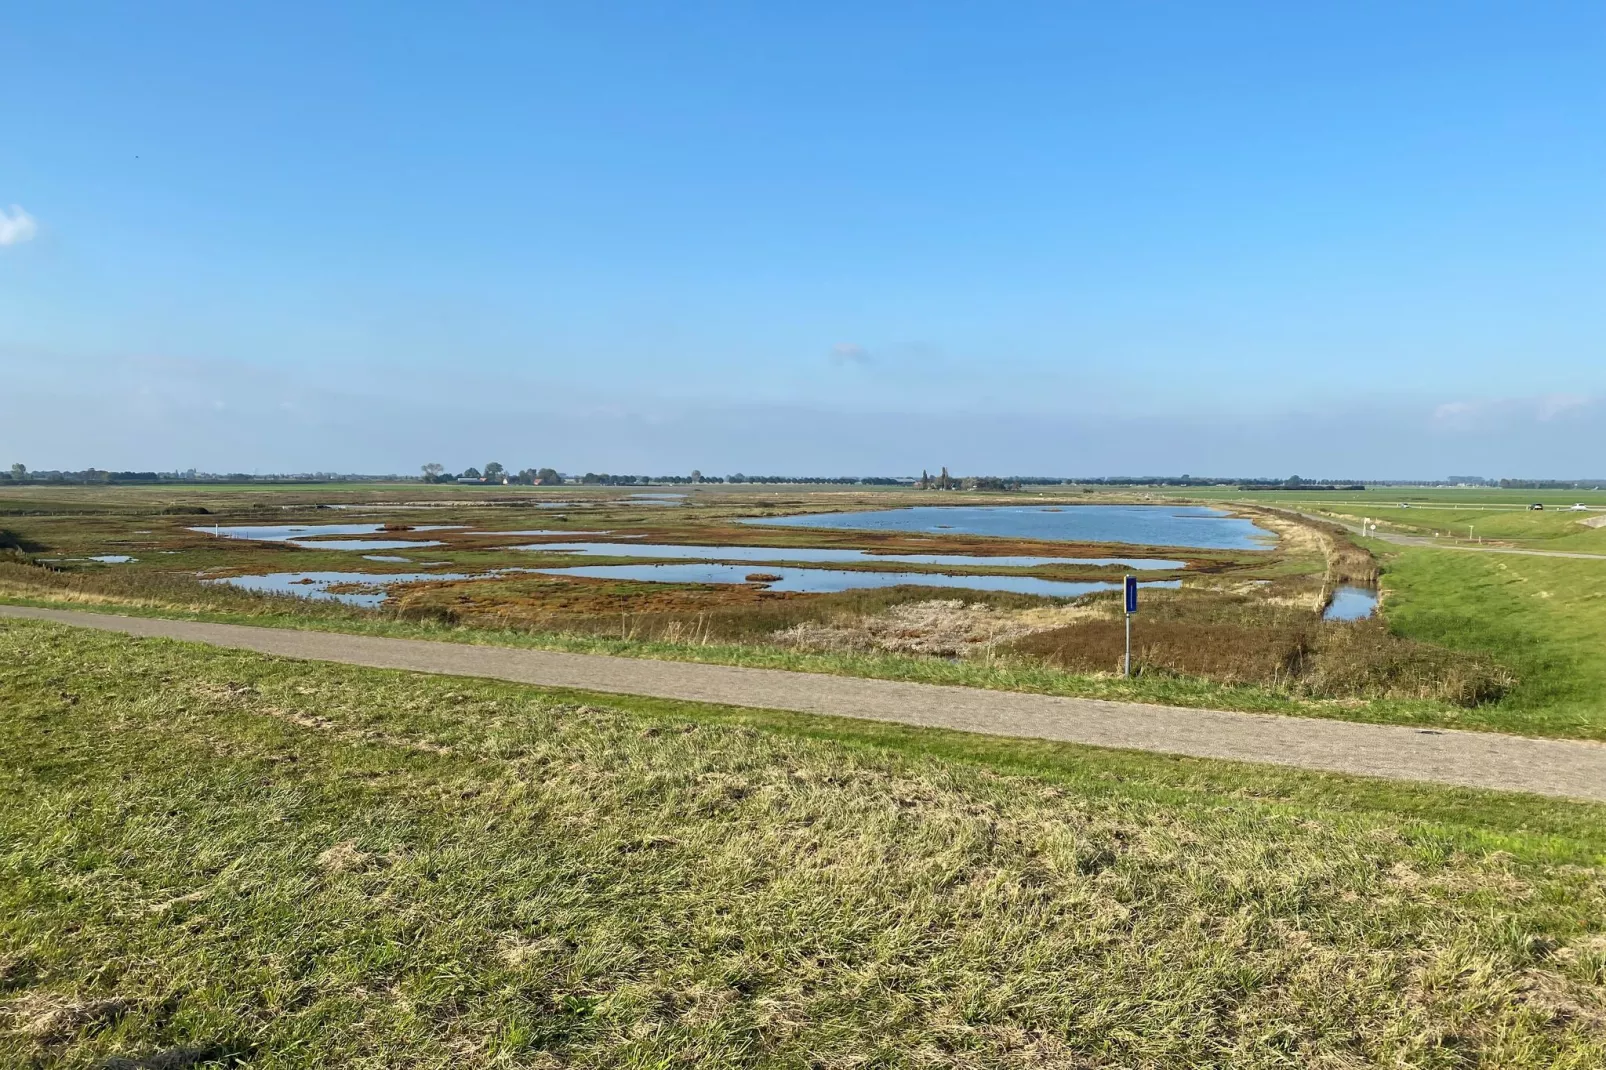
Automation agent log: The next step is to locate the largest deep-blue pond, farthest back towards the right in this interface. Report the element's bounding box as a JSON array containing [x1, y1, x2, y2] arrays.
[[742, 504, 1277, 549]]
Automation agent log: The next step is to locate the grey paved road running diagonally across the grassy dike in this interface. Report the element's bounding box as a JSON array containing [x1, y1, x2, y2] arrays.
[[0, 606, 1606, 802]]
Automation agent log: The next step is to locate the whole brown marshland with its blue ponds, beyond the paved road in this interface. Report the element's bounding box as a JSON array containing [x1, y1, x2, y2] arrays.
[[9, 485, 1606, 737]]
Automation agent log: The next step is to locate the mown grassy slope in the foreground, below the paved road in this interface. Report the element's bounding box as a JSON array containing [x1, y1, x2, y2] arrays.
[[9, 622, 1606, 1068]]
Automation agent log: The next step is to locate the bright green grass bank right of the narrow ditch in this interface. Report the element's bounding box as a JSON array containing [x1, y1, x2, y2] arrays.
[[1384, 549, 1606, 739]]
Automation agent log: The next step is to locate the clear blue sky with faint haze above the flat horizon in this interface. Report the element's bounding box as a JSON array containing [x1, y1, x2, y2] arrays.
[[0, 2, 1606, 477]]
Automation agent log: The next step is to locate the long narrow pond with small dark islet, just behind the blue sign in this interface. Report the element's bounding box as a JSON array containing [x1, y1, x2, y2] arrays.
[[535, 564, 1182, 598]]
